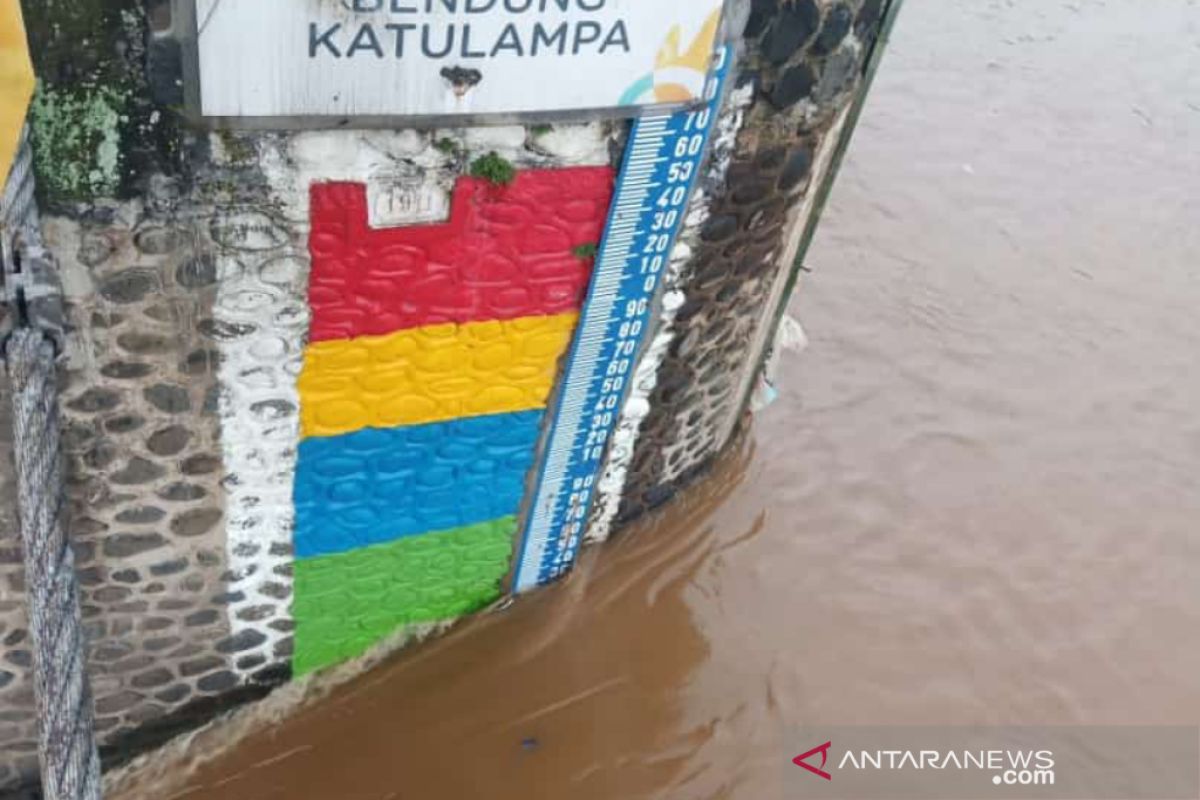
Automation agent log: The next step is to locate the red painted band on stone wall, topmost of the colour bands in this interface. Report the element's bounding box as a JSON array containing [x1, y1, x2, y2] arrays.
[[308, 167, 613, 342]]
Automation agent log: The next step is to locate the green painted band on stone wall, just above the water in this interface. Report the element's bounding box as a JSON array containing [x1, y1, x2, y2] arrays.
[[292, 517, 516, 676]]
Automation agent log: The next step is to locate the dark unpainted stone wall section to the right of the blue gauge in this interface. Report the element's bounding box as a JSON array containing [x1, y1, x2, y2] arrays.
[[618, 0, 883, 521]]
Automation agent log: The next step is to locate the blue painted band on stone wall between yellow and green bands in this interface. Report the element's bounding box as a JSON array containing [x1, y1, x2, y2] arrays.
[[295, 411, 545, 558]]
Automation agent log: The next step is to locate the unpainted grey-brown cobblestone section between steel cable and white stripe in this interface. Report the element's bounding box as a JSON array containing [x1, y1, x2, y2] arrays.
[[44, 195, 241, 740]]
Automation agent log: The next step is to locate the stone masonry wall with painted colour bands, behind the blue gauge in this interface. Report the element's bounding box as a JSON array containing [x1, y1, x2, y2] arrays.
[[0, 0, 884, 793]]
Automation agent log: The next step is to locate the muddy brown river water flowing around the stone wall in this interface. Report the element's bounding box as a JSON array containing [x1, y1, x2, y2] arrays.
[[112, 0, 1200, 800]]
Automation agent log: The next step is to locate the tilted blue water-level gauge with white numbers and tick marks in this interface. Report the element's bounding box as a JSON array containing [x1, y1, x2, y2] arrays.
[[512, 47, 732, 593]]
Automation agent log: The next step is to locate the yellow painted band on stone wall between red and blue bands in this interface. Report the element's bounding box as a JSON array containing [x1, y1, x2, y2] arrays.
[[299, 313, 578, 437]]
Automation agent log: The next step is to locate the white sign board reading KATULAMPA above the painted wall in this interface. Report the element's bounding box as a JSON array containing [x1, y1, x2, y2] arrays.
[[194, 0, 724, 118]]
